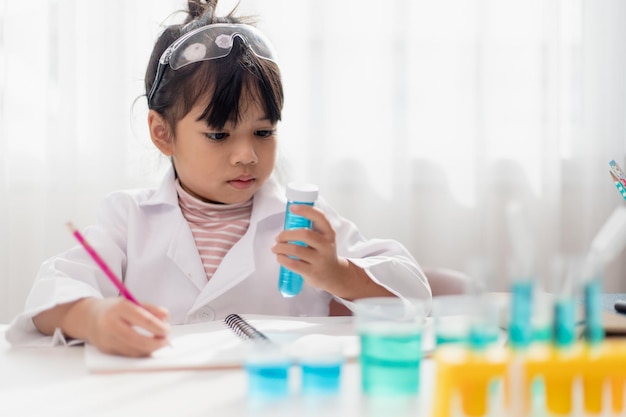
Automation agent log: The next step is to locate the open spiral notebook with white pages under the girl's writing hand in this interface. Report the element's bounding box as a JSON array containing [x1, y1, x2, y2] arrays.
[[85, 314, 359, 373]]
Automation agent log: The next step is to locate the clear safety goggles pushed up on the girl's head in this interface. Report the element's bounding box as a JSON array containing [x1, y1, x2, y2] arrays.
[[148, 23, 276, 103]]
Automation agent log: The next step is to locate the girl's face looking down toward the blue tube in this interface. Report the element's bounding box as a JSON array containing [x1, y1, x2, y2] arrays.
[[151, 99, 276, 204]]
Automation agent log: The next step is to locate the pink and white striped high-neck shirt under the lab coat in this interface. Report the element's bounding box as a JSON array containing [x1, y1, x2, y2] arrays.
[[176, 180, 252, 280]]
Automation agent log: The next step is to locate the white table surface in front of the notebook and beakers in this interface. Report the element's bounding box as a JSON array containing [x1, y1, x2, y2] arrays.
[[0, 325, 434, 417]]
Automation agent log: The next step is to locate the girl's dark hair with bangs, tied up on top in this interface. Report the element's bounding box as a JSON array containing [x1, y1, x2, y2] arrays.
[[145, 0, 283, 133]]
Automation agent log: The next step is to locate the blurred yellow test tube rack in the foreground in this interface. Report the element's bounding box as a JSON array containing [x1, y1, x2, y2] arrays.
[[431, 339, 626, 417]]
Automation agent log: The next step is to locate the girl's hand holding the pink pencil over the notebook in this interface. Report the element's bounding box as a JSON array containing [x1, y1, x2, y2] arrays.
[[72, 297, 170, 357]]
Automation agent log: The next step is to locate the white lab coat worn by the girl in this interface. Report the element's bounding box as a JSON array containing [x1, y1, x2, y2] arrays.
[[6, 166, 431, 345]]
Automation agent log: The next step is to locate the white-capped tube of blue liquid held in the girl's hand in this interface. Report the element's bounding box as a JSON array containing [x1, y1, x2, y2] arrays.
[[278, 182, 319, 297]]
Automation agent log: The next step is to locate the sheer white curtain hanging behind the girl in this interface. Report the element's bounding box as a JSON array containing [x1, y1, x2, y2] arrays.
[[0, 0, 626, 322]]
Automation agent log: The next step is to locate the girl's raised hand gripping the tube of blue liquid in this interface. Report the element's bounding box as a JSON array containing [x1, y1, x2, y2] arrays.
[[272, 204, 349, 294]]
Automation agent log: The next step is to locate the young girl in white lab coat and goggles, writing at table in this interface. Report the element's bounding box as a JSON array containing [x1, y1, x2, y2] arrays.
[[7, 0, 431, 356]]
